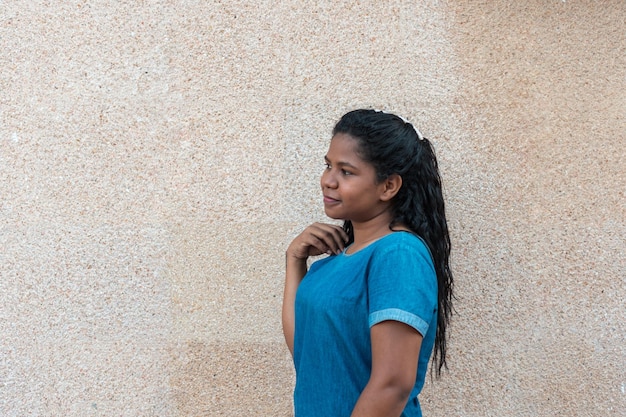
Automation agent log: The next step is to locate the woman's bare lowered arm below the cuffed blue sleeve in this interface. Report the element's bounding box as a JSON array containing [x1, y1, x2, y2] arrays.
[[352, 320, 422, 417]]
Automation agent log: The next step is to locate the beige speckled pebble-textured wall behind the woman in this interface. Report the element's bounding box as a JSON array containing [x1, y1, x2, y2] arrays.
[[0, 0, 626, 417]]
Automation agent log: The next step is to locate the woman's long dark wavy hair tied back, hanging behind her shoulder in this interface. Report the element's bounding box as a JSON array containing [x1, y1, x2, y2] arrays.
[[333, 109, 454, 376]]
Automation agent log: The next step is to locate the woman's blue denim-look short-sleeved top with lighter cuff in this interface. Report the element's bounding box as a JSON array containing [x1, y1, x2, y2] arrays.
[[294, 232, 437, 417]]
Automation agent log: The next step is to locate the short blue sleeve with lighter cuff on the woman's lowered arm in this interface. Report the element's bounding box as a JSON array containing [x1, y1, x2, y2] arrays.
[[367, 235, 437, 336]]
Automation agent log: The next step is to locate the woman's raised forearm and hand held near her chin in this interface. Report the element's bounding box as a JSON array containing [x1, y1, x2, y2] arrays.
[[282, 223, 348, 355]]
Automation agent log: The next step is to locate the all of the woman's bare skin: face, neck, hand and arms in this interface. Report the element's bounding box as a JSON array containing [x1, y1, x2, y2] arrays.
[[282, 133, 422, 417]]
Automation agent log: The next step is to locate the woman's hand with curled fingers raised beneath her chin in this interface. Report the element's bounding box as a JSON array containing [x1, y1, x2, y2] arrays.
[[287, 223, 348, 260]]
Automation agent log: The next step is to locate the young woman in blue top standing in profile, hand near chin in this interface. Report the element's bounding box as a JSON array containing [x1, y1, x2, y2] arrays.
[[283, 110, 453, 417]]
